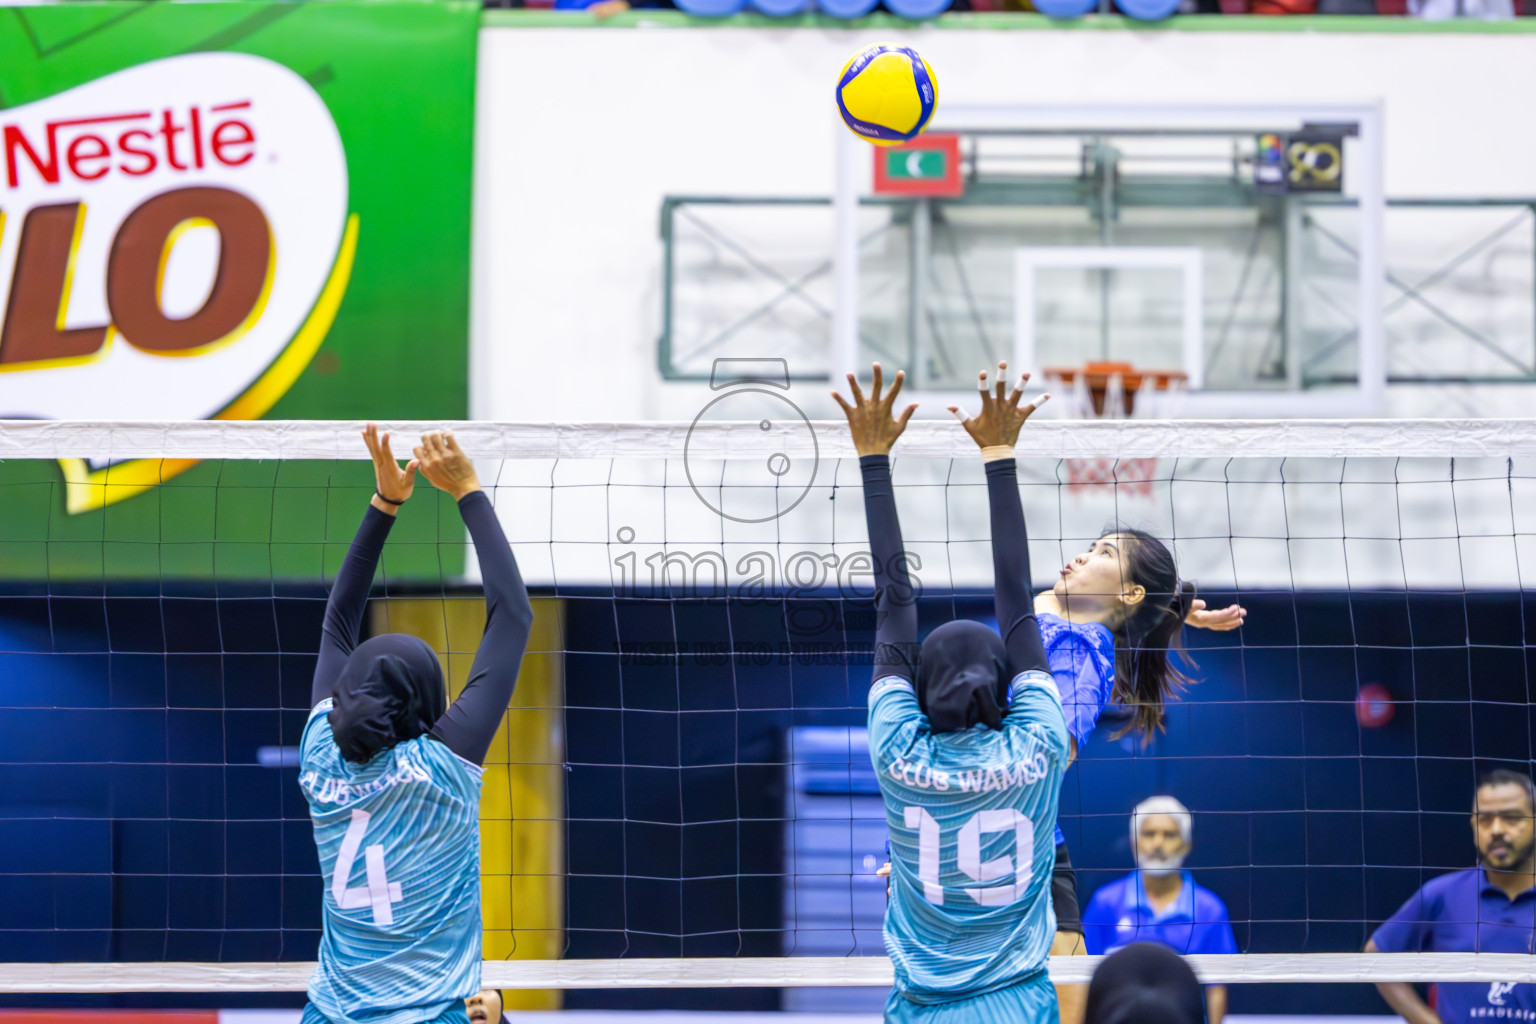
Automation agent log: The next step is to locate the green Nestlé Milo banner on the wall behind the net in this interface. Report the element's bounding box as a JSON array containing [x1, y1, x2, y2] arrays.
[[0, 0, 479, 577]]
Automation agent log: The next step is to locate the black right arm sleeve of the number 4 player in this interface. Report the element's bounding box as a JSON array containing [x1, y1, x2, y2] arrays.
[[432, 491, 533, 765]]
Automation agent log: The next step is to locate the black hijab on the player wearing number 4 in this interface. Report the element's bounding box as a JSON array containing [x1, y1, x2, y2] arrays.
[[330, 633, 447, 765]]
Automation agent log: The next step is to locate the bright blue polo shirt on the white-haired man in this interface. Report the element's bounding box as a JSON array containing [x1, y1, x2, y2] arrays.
[[1083, 870, 1238, 956]]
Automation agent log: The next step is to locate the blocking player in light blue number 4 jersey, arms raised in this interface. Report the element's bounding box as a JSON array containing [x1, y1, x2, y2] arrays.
[[298, 451, 533, 1024]]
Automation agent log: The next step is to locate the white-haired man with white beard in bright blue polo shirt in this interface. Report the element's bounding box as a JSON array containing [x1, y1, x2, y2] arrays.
[[1083, 797, 1238, 1024]]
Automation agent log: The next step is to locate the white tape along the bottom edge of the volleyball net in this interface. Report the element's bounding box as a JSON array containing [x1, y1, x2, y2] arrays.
[[9, 953, 1536, 992]]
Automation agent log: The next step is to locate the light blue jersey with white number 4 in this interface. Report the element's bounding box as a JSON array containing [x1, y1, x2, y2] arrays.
[[300, 700, 481, 1024]]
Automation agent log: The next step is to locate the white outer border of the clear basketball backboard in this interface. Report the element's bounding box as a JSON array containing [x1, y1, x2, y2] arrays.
[[831, 101, 1387, 419]]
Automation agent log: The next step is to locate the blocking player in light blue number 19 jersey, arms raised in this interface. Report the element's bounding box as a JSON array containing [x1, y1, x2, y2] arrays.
[[837, 380, 1071, 1024]]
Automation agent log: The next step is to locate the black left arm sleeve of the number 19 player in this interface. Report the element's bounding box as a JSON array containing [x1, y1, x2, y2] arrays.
[[859, 454, 917, 682]]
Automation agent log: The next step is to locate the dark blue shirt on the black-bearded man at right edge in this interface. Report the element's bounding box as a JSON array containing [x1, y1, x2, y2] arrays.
[[1372, 867, 1536, 1024]]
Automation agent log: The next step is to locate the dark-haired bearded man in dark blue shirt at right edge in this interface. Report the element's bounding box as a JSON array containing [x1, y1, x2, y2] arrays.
[[1366, 769, 1536, 1024]]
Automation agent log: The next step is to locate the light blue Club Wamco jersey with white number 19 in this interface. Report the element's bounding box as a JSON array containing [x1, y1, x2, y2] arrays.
[[869, 672, 1068, 1003]]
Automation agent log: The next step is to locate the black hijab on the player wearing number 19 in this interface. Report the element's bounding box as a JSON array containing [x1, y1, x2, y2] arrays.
[[917, 619, 1009, 732]]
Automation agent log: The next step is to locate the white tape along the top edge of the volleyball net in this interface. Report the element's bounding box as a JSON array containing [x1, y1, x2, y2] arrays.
[[0, 419, 1536, 461]]
